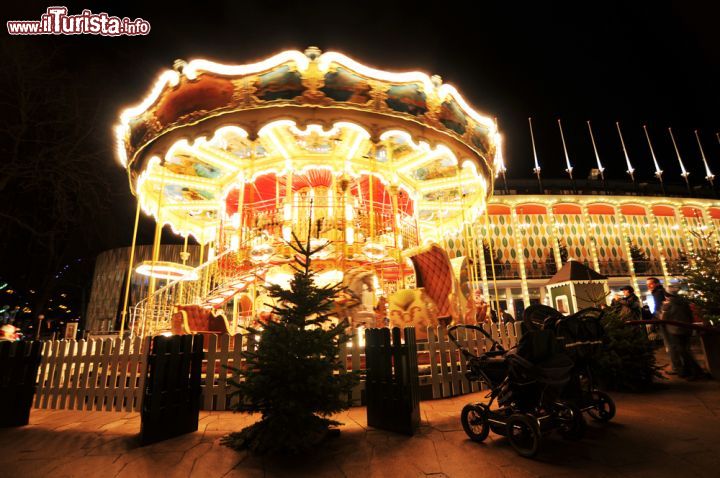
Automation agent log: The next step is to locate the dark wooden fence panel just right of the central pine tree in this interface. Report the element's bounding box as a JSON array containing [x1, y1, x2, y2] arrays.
[[365, 327, 420, 435]]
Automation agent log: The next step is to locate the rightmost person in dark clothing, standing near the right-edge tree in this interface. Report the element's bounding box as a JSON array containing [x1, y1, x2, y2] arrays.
[[660, 285, 703, 378]]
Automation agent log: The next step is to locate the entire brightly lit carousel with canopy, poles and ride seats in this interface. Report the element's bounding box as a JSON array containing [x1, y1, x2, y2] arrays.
[[116, 48, 500, 336]]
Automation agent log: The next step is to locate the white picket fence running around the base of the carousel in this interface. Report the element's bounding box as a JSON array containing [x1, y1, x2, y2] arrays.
[[35, 323, 520, 412]]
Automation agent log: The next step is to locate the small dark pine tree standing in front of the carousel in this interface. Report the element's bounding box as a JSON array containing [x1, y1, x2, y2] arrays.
[[223, 235, 358, 454]]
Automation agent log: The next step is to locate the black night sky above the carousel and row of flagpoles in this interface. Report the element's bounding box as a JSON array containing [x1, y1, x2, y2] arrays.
[[0, 1, 720, 296]]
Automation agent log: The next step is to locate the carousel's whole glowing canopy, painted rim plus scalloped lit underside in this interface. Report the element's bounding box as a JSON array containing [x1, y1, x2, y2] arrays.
[[116, 48, 500, 242]]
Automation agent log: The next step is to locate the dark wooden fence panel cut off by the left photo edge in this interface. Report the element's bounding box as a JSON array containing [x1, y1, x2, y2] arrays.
[[0, 341, 42, 427]]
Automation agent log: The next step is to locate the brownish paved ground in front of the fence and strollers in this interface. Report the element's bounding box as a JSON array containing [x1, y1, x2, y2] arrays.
[[0, 370, 720, 478]]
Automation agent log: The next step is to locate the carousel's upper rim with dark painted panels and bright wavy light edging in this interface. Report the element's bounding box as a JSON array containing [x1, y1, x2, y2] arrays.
[[115, 47, 499, 176]]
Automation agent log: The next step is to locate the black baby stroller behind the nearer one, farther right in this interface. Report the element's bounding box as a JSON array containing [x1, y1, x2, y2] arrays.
[[523, 305, 615, 422]]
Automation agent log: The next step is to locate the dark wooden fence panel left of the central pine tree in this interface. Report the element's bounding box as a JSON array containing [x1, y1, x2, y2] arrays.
[[140, 335, 203, 445]]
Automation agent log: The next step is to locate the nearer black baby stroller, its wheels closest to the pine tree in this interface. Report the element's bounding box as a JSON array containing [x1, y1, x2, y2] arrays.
[[448, 325, 584, 458]]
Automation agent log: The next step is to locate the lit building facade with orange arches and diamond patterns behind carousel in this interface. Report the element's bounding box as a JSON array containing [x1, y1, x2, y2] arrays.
[[458, 185, 720, 320]]
